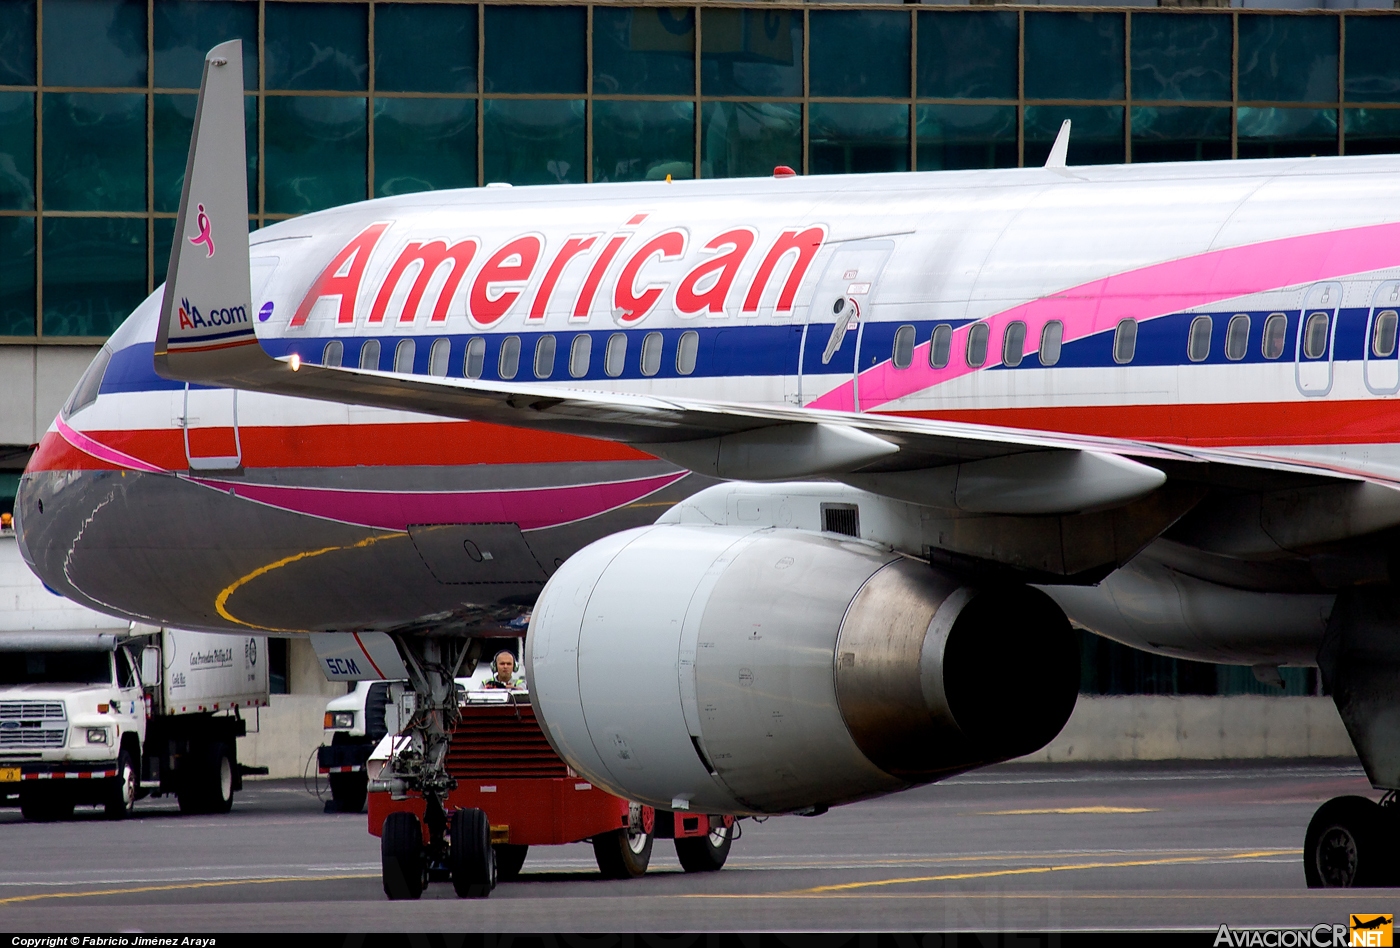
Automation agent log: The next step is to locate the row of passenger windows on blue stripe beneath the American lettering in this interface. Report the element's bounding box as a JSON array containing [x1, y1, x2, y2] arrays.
[[321, 329, 700, 381]]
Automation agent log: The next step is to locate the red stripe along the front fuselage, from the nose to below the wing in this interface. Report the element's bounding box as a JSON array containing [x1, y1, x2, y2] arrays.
[[28, 421, 651, 470]]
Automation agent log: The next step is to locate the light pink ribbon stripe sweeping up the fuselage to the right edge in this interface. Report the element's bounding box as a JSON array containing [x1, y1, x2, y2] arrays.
[[811, 224, 1400, 412]]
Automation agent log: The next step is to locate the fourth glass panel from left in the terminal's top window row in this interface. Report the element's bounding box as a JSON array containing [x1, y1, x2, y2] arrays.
[[263, 3, 370, 91]]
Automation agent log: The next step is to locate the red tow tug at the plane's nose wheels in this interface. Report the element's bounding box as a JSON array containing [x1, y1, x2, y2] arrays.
[[365, 689, 736, 899]]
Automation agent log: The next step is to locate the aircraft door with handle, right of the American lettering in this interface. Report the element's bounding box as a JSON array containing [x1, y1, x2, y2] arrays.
[[802, 239, 895, 405]]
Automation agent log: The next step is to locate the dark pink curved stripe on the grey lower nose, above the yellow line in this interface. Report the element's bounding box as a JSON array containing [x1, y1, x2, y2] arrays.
[[192, 470, 686, 529]]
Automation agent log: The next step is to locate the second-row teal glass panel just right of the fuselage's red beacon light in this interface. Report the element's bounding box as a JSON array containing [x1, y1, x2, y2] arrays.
[[808, 102, 909, 175]]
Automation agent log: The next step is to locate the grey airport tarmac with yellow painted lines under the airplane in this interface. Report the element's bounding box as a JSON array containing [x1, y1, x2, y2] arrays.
[[0, 760, 1383, 934]]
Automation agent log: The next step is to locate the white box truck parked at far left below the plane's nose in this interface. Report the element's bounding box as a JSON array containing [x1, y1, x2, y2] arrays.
[[0, 531, 269, 821]]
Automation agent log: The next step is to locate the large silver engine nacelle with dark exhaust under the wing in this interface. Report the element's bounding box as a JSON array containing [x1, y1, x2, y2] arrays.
[[525, 524, 1079, 814]]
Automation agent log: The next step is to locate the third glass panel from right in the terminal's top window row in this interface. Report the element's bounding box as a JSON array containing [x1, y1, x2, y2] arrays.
[[1133, 13, 1232, 101]]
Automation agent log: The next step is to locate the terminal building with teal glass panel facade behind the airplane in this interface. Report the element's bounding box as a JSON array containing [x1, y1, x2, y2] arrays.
[[0, 0, 1400, 705]]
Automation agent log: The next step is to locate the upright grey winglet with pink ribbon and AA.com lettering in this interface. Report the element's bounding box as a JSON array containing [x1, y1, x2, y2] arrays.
[[155, 39, 273, 382]]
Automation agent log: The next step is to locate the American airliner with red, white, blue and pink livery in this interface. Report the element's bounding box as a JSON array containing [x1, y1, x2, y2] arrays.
[[15, 43, 1400, 885]]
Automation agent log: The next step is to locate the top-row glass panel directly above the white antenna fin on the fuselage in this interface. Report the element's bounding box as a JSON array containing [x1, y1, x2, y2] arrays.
[[1026, 13, 1123, 100]]
